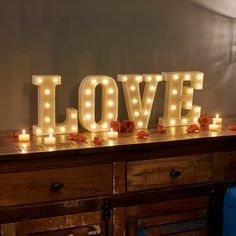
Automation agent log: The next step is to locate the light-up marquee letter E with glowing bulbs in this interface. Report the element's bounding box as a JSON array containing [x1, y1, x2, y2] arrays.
[[159, 72, 204, 126]]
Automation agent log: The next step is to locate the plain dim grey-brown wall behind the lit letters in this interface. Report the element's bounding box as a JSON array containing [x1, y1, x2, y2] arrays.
[[0, 0, 236, 130]]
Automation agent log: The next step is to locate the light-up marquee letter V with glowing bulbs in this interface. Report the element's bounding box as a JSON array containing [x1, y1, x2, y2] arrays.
[[118, 74, 162, 129]]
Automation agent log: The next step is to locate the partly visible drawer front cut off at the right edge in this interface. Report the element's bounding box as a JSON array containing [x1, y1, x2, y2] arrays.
[[224, 152, 236, 180]]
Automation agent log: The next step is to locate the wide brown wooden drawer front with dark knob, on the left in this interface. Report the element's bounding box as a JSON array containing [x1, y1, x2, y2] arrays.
[[0, 164, 112, 206]]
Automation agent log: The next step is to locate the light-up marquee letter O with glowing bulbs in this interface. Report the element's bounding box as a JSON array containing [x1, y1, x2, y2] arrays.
[[79, 75, 118, 132]]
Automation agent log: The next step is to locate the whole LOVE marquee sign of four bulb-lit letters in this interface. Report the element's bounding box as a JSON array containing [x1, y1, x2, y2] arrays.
[[32, 71, 204, 136]]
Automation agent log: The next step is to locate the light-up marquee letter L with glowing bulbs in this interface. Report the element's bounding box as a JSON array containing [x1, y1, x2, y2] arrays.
[[32, 75, 78, 136]]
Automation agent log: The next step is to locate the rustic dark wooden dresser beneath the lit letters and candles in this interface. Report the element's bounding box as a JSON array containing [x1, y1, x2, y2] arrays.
[[0, 127, 236, 236]]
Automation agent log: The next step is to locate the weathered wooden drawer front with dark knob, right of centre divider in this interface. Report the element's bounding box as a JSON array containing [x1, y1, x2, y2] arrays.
[[127, 154, 213, 191]]
